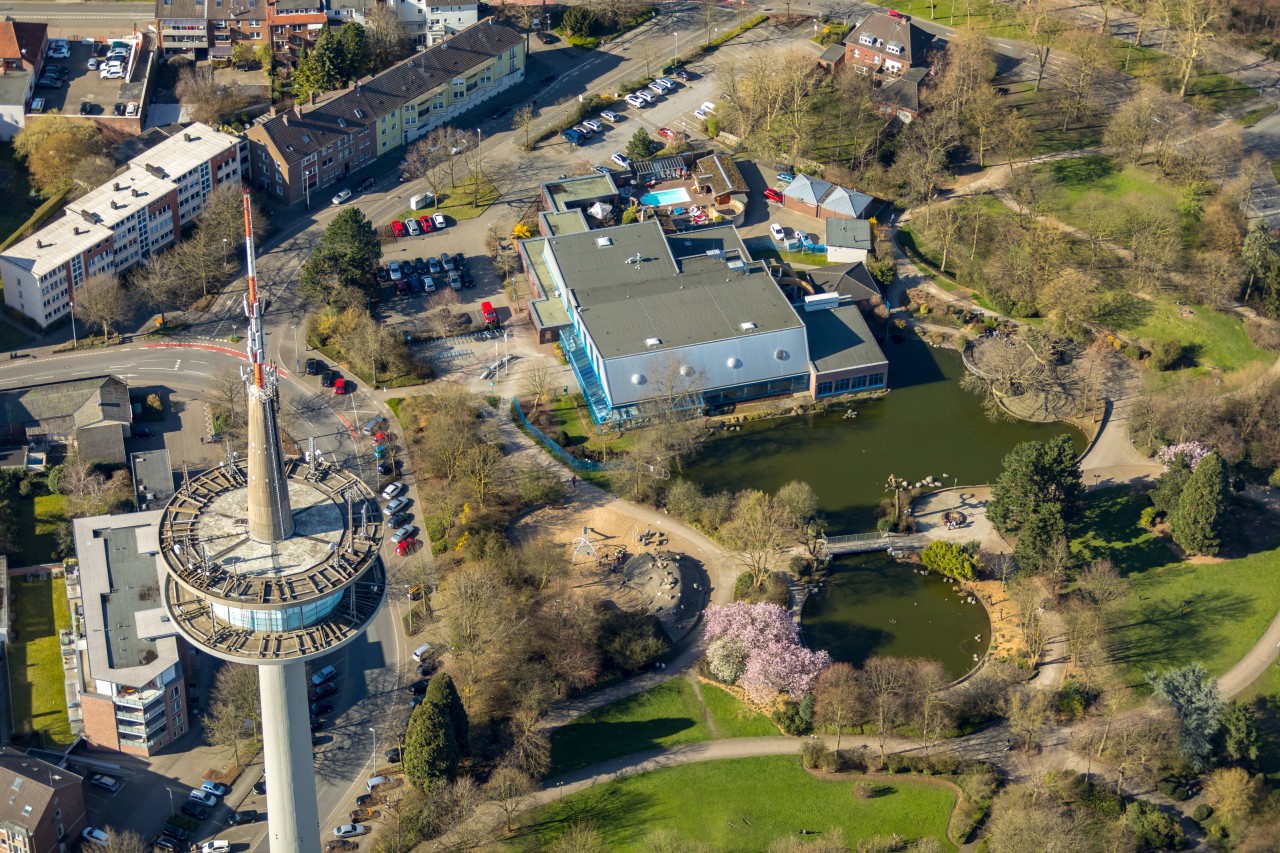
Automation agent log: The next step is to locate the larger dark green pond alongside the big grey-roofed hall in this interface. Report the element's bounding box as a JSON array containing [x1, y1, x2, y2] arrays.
[[685, 336, 1084, 534]]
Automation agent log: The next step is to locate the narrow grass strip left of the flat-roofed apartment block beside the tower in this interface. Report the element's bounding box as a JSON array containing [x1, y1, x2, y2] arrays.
[[9, 578, 72, 745]]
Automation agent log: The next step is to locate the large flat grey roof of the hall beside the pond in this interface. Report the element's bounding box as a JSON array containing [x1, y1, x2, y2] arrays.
[[548, 219, 800, 359]]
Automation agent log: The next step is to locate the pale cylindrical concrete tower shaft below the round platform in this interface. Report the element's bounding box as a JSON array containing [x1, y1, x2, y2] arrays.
[[257, 661, 321, 853]]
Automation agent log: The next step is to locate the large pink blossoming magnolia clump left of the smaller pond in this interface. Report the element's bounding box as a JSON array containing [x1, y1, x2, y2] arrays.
[[704, 602, 831, 704]]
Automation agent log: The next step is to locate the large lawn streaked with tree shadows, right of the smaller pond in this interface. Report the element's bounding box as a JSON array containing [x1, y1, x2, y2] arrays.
[[1110, 549, 1280, 685]]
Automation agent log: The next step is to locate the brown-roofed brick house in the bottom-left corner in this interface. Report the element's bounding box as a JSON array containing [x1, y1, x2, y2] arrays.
[[0, 747, 86, 853]]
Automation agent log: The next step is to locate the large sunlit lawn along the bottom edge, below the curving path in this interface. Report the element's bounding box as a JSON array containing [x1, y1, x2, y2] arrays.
[[508, 756, 956, 853]]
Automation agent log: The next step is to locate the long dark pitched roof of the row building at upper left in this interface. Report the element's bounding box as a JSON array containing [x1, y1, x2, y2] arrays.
[[250, 23, 525, 163]]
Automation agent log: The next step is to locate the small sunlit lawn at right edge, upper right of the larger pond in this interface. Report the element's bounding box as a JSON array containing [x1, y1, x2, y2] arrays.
[[1121, 297, 1275, 371]]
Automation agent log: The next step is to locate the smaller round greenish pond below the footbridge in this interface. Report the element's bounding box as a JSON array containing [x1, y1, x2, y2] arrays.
[[800, 553, 991, 679]]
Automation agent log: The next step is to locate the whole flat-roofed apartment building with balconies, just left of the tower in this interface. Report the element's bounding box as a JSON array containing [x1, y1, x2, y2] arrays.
[[68, 510, 191, 756]]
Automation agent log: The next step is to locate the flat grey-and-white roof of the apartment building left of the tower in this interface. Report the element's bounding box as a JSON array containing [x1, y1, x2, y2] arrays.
[[73, 510, 178, 688]]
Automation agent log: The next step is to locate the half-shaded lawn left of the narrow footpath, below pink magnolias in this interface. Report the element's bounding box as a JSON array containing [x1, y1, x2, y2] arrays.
[[548, 678, 712, 776]]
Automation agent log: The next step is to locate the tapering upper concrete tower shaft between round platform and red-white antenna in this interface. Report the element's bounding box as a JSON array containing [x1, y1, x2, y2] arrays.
[[246, 384, 293, 542]]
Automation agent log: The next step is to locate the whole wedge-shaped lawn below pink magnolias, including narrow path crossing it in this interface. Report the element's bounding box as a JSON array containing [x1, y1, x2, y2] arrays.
[[549, 678, 780, 776]]
